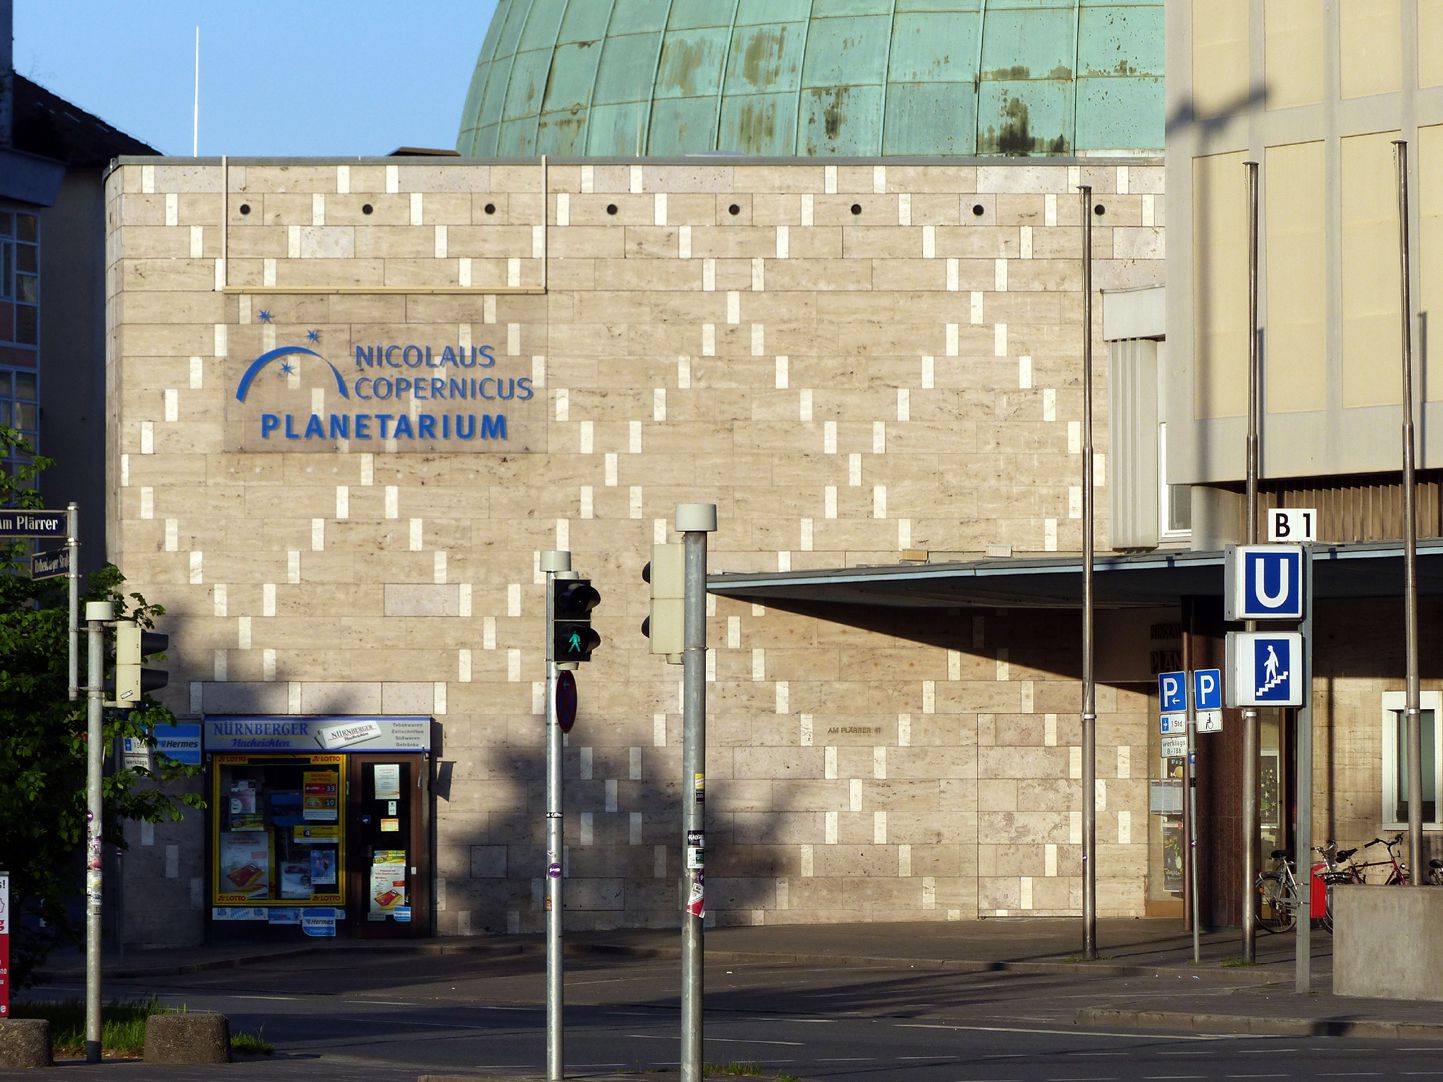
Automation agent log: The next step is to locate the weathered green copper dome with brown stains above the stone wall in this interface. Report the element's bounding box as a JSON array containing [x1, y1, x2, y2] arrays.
[[456, 0, 1163, 157]]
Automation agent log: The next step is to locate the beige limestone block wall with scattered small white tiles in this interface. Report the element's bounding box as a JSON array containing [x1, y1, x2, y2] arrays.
[[107, 159, 1165, 944]]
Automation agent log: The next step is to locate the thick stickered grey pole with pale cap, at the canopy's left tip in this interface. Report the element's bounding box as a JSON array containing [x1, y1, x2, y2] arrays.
[[675, 503, 717, 1082]]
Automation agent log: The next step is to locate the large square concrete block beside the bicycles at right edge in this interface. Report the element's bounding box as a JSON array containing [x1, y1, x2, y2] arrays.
[[1333, 884, 1443, 1000]]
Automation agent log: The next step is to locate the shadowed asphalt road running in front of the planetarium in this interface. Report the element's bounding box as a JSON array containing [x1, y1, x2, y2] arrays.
[[19, 954, 1443, 1082]]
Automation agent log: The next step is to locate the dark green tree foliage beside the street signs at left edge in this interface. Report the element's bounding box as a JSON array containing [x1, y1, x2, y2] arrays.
[[0, 427, 203, 985]]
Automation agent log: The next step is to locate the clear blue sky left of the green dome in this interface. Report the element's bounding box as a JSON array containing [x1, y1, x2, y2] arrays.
[[14, 0, 495, 157]]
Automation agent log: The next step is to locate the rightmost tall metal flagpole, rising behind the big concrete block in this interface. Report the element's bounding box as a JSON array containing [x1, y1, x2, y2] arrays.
[[1392, 138, 1429, 887]]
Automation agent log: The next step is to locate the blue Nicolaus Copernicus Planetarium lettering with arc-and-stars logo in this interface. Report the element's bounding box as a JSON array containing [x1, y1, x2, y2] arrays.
[[235, 343, 535, 441]]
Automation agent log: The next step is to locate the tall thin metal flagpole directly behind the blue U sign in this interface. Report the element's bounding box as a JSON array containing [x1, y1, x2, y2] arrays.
[[1242, 162, 1263, 962]]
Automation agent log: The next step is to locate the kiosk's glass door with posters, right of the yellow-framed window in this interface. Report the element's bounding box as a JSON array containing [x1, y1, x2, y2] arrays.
[[346, 753, 430, 938]]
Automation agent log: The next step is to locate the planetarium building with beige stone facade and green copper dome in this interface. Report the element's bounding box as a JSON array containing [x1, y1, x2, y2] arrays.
[[107, 0, 1284, 945]]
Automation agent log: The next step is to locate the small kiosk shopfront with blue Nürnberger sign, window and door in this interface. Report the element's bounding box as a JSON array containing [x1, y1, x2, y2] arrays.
[[205, 716, 431, 936]]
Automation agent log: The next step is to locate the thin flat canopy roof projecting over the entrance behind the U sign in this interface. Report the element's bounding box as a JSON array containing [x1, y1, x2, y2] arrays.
[[707, 538, 1443, 609]]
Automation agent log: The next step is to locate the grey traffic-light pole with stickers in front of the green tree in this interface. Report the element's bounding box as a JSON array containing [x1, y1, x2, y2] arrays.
[[85, 602, 115, 1063]]
